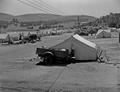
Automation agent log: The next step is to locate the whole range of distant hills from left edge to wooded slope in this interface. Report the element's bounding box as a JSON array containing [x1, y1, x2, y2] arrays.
[[0, 13, 96, 22]]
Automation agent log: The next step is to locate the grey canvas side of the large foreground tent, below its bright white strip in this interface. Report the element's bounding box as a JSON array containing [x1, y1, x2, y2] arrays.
[[72, 39, 97, 60]]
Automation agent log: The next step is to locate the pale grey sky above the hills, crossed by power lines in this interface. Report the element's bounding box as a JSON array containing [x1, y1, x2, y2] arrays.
[[0, 0, 120, 17]]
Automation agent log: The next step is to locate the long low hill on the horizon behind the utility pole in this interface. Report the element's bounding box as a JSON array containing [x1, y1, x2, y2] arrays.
[[16, 14, 96, 22]]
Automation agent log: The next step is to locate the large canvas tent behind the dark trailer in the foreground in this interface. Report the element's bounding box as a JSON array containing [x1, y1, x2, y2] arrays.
[[51, 34, 97, 60]]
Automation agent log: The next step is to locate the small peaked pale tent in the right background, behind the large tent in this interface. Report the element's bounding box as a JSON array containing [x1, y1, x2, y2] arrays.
[[96, 29, 111, 38]]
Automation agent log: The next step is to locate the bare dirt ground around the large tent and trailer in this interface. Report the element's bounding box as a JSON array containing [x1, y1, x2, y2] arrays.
[[0, 34, 120, 92]]
